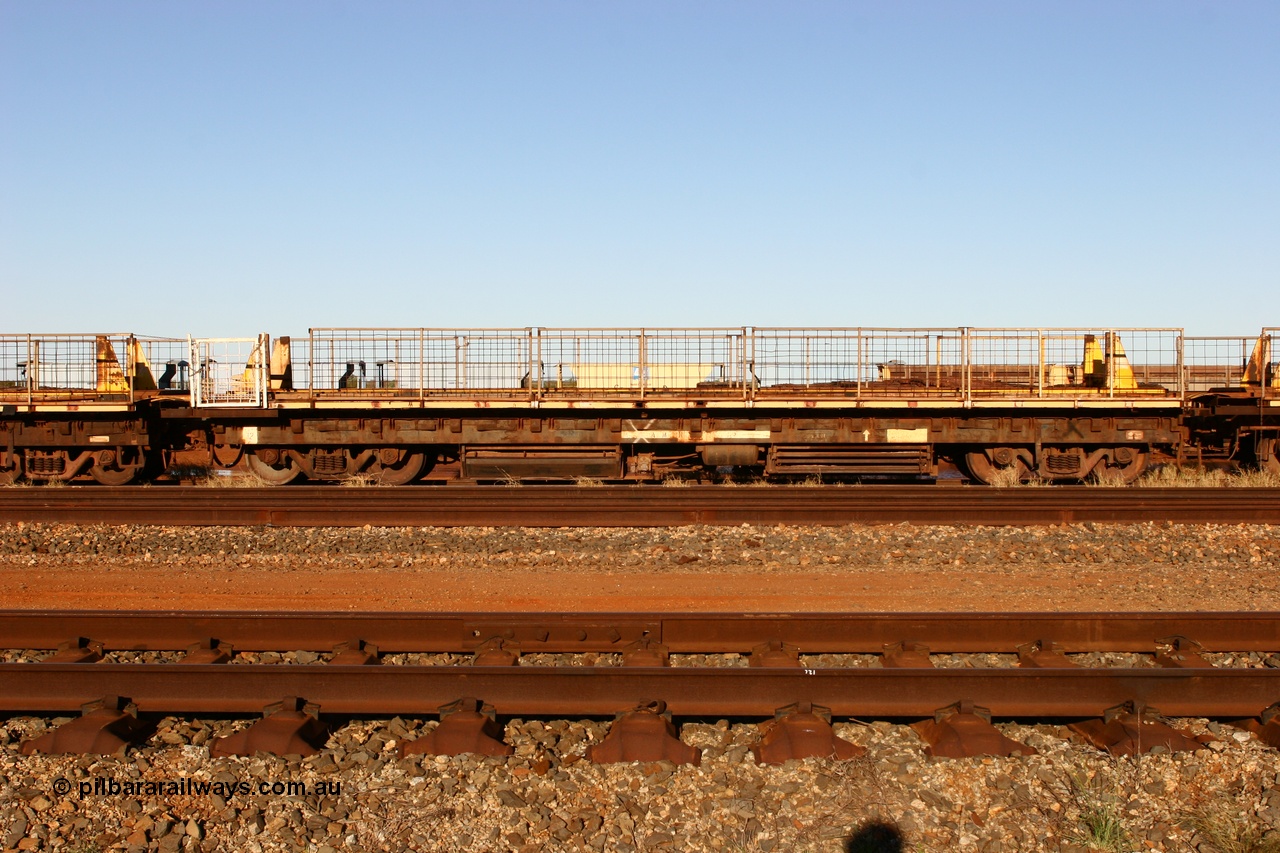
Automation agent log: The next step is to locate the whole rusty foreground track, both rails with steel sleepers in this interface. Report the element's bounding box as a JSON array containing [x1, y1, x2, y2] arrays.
[[0, 612, 1280, 757]]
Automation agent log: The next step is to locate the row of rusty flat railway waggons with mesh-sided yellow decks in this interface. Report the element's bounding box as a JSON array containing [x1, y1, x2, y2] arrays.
[[0, 327, 1280, 484]]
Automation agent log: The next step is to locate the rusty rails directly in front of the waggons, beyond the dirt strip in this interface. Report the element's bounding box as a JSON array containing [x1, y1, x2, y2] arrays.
[[0, 485, 1280, 526]]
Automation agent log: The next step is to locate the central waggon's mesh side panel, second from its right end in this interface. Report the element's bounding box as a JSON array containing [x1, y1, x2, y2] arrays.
[[750, 328, 964, 394]]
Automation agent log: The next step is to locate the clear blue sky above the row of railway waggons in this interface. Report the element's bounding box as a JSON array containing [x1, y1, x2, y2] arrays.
[[0, 0, 1280, 336]]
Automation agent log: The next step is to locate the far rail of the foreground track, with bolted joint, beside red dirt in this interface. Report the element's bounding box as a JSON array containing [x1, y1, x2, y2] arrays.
[[0, 610, 1280, 653]]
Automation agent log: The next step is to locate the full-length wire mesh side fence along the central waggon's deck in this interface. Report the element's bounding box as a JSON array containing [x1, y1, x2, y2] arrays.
[[280, 328, 1187, 397]]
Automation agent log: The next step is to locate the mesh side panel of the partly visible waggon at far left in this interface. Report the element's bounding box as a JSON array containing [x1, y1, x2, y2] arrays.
[[0, 333, 136, 402]]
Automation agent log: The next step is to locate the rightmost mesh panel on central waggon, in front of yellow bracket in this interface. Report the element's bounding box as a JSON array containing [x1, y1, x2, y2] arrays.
[[966, 328, 1181, 397]]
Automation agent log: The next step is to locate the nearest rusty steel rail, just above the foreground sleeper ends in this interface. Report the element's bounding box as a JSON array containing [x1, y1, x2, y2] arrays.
[[0, 663, 1280, 717]]
